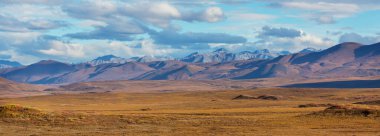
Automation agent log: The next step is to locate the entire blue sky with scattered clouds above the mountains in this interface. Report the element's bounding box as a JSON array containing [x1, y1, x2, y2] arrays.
[[0, 0, 380, 64]]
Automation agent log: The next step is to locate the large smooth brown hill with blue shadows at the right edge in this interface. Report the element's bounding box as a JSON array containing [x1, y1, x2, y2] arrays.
[[235, 43, 380, 79]]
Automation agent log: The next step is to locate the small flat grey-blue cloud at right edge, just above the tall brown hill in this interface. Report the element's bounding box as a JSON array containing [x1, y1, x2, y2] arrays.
[[339, 33, 380, 44]]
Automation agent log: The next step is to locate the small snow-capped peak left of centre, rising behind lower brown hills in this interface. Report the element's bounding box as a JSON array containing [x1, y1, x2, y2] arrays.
[[87, 55, 128, 66]]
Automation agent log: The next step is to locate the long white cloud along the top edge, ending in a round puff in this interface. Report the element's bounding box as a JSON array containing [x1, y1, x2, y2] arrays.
[[63, 0, 225, 28]]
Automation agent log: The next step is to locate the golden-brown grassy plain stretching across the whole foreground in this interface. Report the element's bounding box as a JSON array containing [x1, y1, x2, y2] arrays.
[[0, 88, 380, 136]]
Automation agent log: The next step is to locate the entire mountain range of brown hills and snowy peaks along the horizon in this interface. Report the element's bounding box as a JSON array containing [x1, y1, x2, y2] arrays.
[[0, 43, 380, 84]]
